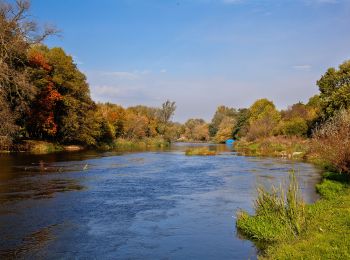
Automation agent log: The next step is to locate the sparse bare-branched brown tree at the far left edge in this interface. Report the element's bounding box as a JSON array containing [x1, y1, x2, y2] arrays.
[[0, 0, 56, 146]]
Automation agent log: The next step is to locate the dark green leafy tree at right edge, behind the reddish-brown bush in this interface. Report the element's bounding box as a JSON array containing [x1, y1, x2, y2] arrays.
[[317, 61, 350, 120]]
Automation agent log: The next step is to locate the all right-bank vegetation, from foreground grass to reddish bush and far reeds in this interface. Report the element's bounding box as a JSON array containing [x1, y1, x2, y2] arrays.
[[235, 110, 350, 259]]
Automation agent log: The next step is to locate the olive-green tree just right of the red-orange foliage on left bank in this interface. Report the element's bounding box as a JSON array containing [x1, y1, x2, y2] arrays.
[[41, 46, 99, 144]]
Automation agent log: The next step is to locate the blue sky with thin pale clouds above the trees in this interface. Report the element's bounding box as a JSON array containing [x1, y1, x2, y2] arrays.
[[30, 0, 350, 122]]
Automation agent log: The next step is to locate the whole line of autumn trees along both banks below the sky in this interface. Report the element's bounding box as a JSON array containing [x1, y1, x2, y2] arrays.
[[0, 0, 350, 150]]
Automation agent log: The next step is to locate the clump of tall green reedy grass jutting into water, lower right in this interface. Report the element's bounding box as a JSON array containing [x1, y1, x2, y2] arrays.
[[236, 172, 306, 242]]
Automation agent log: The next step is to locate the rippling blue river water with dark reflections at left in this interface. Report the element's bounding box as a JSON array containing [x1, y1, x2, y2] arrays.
[[0, 144, 319, 259]]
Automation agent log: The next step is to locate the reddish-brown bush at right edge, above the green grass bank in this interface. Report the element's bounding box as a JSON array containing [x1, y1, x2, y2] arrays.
[[312, 110, 350, 173]]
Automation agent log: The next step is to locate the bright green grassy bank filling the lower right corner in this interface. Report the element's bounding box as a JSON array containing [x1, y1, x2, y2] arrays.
[[237, 173, 350, 259]]
